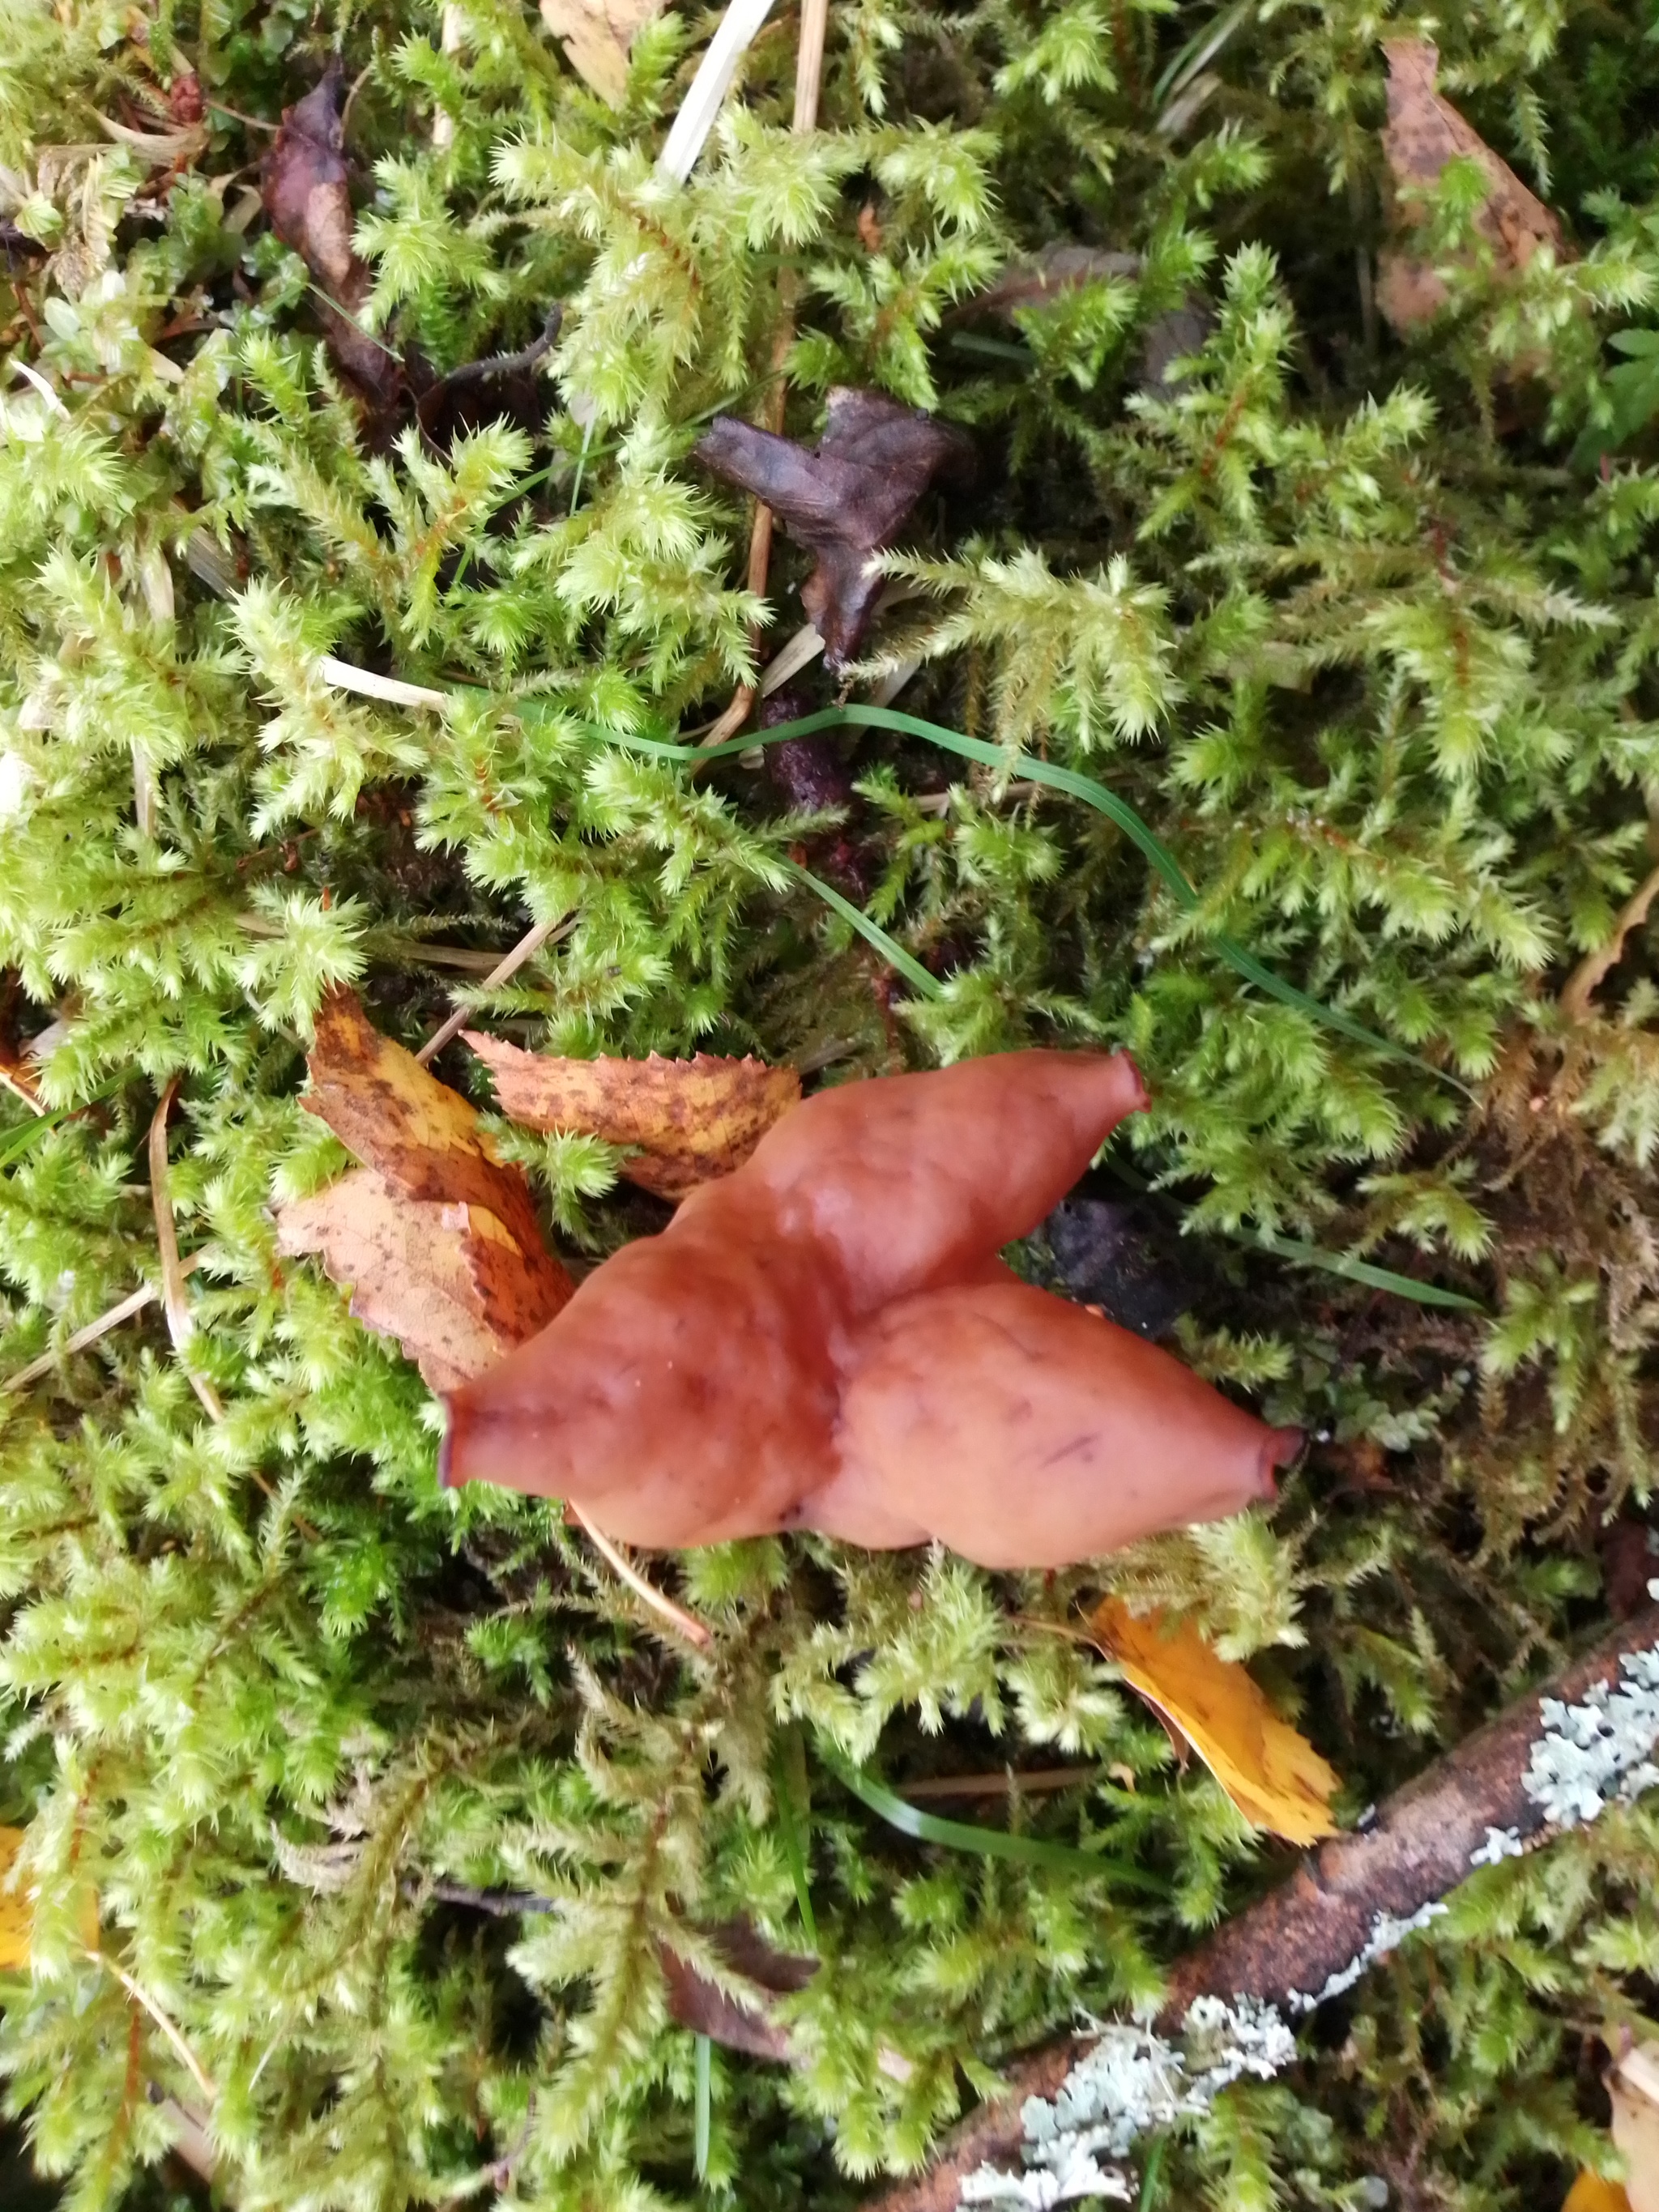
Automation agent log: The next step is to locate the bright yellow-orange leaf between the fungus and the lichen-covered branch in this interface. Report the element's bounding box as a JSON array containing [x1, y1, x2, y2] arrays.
[[1088, 1597, 1338, 1843]]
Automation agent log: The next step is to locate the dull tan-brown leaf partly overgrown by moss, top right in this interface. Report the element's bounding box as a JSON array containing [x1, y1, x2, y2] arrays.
[[1378, 37, 1562, 330]]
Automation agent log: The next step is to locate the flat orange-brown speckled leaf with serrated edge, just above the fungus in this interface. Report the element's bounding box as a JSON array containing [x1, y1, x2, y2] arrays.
[[463, 1029, 801, 1199]]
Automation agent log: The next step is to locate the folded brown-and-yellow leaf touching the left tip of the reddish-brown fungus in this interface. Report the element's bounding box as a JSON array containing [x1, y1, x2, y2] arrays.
[[276, 991, 571, 1389]]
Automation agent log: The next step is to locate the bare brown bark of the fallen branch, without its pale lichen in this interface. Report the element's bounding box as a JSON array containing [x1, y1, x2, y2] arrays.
[[865, 1606, 1659, 2212]]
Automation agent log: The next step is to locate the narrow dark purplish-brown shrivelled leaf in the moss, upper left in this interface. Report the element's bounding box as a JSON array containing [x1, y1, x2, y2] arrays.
[[261, 60, 403, 407]]
